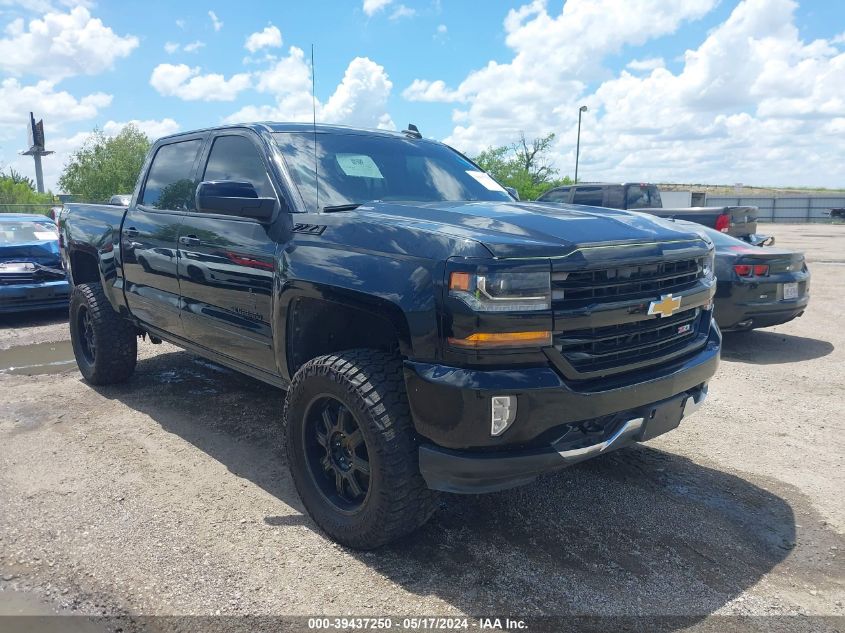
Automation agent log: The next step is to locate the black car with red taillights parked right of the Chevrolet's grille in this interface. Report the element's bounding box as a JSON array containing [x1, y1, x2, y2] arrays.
[[675, 220, 810, 332]]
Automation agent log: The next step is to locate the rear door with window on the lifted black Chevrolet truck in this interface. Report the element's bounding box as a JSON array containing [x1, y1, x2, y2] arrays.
[[121, 137, 203, 336]]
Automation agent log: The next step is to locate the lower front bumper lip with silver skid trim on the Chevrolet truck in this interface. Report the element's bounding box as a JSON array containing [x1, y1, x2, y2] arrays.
[[419, 385, 707, 494]]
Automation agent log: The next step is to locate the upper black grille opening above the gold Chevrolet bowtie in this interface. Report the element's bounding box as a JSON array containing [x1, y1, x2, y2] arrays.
[[552, 258, 704, 310]]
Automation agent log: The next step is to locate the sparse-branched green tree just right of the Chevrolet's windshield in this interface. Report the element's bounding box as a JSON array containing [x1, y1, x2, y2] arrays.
[[473, 133, 572, 200]]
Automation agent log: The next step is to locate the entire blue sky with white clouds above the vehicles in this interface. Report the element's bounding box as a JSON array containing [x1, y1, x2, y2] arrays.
[[0, 0, 845, 187]]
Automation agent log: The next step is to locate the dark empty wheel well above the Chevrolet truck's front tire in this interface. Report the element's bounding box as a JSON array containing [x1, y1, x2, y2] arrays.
[[287, 298, 406, 376]]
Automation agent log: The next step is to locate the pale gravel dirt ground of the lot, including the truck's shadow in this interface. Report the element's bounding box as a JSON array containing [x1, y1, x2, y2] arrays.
[[0, 225, 845, 631]]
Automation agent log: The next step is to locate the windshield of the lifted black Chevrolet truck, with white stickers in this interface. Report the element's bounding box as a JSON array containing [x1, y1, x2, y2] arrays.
[[274, 132, 513, 212]]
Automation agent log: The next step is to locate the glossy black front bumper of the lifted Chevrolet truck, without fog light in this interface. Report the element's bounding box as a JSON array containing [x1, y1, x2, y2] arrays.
[[405, 321, 722, 492]]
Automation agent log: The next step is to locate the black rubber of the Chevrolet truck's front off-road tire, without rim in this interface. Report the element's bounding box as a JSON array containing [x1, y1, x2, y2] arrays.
[[284, 349, 437, 549]]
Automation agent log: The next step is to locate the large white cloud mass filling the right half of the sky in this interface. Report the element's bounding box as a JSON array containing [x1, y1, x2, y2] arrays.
[[403, 0, 845, 185]]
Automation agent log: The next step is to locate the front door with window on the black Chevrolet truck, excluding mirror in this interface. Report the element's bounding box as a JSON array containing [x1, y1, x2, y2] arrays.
[[177, 130, 278, 373]]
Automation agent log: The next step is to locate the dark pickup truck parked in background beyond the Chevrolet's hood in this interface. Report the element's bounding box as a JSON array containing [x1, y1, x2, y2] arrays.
[[537, 182, 766, 245]]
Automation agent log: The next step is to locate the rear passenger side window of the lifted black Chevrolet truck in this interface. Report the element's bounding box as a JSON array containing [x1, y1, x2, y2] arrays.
[[141, 139, 202, 211]]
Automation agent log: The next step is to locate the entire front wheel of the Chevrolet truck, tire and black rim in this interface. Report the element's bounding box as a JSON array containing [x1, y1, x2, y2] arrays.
[[284, 349, 436, 549]]
